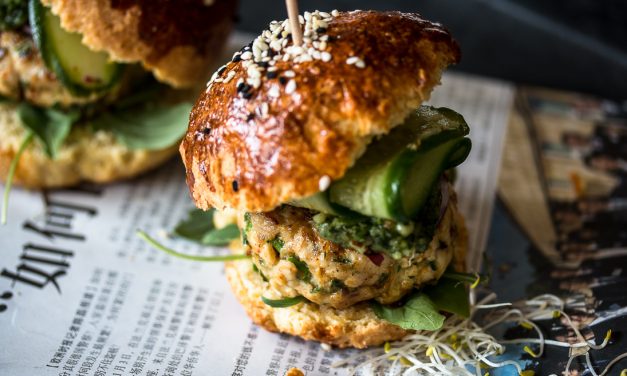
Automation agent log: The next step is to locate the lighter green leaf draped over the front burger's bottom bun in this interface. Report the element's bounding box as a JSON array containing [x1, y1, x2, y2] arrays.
[[372, 293, 445, 330]]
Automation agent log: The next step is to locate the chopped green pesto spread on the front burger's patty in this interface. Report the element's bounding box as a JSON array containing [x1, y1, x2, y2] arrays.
[[312, 190, 441, 259]]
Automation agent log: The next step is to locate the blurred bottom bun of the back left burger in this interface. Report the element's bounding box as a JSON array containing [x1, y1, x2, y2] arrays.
[[0, 103, 178, 188]]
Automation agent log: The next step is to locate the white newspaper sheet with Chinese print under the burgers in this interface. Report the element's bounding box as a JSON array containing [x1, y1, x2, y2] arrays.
[[0, 75, 512, 376]]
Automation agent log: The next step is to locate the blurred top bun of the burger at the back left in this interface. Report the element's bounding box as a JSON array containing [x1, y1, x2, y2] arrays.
[[42, 0, 237, 87]]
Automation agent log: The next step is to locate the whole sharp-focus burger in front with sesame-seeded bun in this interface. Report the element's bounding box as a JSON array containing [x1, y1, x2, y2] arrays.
[[180, 11, 471, 348]]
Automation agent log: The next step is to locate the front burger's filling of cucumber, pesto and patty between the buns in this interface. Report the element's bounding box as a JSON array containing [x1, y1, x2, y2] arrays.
[[240, 106, 470, 329]]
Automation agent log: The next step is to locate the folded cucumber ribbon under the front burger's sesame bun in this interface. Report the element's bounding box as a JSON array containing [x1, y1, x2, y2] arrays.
[[329, 106, 471, 222]]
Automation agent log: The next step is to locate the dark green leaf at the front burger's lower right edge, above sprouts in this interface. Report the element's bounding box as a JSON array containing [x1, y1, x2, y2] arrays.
[[423, 278, 470, 317]]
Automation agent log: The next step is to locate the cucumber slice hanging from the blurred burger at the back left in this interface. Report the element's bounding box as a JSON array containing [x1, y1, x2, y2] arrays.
[[29, 0, 122, 95]]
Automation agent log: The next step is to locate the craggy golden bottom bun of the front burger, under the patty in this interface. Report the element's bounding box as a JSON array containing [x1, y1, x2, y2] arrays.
[[226, 207, 467, 348]]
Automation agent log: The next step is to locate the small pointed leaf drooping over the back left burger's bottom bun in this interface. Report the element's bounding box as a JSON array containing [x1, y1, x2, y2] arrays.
[[17, 102, 80, 159]]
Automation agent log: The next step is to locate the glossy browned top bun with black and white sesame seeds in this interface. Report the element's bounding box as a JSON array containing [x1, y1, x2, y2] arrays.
[[180, 11, 460, 211]]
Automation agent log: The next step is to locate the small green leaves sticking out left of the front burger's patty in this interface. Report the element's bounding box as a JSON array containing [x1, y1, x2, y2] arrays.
[[174, 209, 239, 246]]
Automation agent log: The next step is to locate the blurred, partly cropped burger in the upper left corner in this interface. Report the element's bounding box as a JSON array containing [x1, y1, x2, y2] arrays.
[[0, 0, 236, 188]]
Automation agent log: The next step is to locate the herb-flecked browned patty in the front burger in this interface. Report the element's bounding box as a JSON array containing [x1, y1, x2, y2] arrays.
[[240, 189, 466, 308]]
